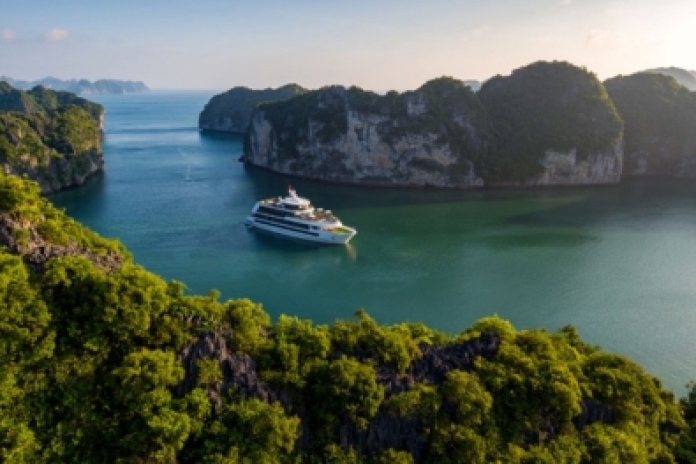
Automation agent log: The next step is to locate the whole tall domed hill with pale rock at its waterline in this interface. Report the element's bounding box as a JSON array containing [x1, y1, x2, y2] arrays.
[[478, 62, 623, 186]]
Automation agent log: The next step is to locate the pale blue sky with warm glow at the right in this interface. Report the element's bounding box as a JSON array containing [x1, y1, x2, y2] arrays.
[[0, 0, 696, 91]]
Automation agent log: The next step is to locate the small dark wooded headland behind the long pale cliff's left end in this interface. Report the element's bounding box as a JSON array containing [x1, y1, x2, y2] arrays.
[[198, 84, 306, 132]]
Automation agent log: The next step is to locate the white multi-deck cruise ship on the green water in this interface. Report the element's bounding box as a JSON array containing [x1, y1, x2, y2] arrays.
[[246, 187, 357, 245]]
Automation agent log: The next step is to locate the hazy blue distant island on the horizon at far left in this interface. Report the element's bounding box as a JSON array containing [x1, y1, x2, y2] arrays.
[[0, 76, 150, 95]]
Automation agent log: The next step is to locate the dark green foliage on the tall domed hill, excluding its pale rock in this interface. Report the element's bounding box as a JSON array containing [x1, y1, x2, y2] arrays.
[[477, 62, 623, 180]]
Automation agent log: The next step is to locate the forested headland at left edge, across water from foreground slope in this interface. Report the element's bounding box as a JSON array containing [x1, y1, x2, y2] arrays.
[[0, 81, 104, 192]]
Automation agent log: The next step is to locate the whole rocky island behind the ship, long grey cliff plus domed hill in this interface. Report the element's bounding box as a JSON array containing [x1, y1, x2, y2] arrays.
[[245, 62, 623, 188]]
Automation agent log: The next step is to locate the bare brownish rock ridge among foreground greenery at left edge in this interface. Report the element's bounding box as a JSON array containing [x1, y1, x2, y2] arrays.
[[0, 213, 125, 272]]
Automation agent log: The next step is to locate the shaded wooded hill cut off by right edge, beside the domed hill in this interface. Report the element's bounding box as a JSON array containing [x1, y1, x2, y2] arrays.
[[604, 73, 696, 175]]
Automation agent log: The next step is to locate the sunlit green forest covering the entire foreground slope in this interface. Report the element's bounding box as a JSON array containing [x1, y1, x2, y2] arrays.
[[0, 174, 696, 463]]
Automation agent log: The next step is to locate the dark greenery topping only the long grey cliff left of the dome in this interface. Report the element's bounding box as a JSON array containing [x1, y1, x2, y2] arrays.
[[246, 77, 487, 178]]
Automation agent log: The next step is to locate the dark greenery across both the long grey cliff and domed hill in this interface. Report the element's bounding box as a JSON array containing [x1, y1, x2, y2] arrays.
[[245, 62, 623, 186]]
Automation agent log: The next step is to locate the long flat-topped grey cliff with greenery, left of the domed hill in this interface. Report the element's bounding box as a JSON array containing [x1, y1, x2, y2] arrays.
[[245, 79, 487, 187]]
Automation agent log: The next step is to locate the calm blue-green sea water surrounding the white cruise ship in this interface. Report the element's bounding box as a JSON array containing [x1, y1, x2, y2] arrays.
[[51, 92, 696, 394]]
